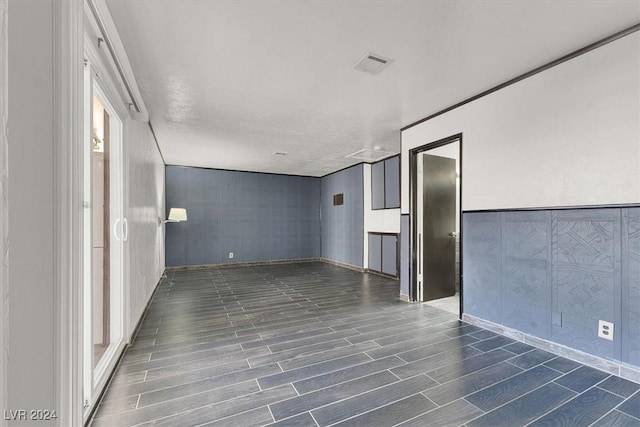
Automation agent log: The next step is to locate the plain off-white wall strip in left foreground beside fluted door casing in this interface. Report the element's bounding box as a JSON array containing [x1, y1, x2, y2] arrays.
[[7, 0, 58, 416]]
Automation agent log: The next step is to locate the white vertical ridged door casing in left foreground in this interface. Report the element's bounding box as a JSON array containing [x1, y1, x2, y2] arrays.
[[52, 0, 84, 426]]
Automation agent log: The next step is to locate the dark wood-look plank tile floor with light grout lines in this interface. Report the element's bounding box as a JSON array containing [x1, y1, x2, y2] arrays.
[[92, 262, 640, 427]]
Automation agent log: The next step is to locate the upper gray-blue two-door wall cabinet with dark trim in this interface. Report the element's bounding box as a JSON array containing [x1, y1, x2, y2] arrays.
[[371, 156, 400, 209]]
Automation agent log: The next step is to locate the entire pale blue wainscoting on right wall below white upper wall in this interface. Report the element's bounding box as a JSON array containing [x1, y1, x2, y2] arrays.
[[463, 208, 640, 372]]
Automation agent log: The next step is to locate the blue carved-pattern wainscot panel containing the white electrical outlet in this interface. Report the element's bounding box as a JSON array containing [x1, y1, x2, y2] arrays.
[[552, 209, 621, 359]]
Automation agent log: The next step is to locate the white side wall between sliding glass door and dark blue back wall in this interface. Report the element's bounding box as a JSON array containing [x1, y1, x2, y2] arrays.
[[125, 120, 165, 337]]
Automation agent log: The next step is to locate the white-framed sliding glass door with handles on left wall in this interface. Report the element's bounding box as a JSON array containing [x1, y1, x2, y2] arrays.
[[83, 67, 127, 416]]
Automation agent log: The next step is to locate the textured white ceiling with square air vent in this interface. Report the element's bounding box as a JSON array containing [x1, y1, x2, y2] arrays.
[[107, 0, 640, 176]]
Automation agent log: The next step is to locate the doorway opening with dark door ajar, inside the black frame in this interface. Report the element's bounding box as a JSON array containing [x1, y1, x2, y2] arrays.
[[409, 134, 462, 316]]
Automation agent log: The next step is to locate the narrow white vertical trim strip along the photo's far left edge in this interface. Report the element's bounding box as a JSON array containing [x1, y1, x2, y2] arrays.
[[0, 0, 9, 427]]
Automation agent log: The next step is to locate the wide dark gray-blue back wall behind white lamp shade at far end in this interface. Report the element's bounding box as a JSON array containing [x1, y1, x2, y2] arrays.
[[166, 166, 321, 267]]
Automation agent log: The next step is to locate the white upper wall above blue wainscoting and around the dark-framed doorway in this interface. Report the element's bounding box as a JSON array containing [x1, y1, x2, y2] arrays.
[[401, 32, 640, 213]]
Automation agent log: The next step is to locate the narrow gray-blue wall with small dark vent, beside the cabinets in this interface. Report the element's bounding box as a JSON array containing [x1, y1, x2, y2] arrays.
[[321, 164, 364, 267]]
